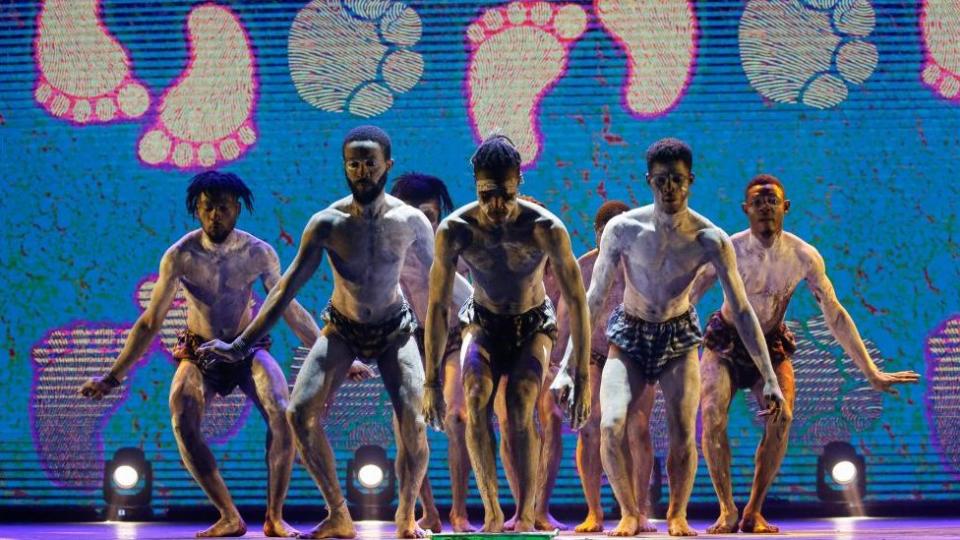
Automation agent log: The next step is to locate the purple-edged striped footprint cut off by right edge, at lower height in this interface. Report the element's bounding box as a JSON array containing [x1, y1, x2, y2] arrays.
[[924, 315, 960, 479]]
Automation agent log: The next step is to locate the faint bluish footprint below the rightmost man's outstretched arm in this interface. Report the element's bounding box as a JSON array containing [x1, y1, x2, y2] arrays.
[[747, 316, 884, 449]]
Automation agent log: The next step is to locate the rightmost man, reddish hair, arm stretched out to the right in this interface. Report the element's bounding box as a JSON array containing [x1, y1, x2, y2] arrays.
[[692, 174, 919, 533]]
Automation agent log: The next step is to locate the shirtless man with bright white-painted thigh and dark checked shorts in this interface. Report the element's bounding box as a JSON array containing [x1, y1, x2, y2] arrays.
[[554, 139, 783, 536]]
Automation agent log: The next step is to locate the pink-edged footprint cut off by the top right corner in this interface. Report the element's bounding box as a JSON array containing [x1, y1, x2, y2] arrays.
[[920, 0, 960, 100]]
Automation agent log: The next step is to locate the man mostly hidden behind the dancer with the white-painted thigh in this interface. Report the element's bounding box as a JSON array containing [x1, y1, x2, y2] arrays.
[[554, 201, 657, 532]]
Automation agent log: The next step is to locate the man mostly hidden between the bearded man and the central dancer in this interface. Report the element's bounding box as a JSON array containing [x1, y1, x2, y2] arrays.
[[390, 173, 476, 532]]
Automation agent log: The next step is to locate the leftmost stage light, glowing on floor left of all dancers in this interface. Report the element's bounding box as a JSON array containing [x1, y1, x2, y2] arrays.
[[103, 448, 153, 520]]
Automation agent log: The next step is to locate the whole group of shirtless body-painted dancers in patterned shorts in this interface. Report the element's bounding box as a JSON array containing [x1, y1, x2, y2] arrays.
[[80, 126, 919, 538]]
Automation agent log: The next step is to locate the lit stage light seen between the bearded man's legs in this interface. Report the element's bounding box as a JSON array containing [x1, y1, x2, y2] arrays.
[[347, 445, 397, 519]]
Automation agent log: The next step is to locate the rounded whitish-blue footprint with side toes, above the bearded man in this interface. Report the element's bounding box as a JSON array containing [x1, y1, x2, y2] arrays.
[[288, 0, 423, 118]]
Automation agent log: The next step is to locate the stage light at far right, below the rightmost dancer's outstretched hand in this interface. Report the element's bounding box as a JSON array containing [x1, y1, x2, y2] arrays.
[[817, 441, 867, 504]]
